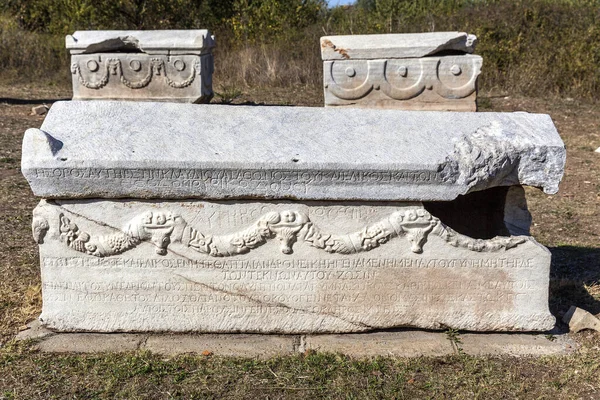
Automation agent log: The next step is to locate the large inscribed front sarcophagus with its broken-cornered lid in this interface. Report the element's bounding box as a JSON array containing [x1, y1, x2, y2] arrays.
[[22, 101, 565, 333]]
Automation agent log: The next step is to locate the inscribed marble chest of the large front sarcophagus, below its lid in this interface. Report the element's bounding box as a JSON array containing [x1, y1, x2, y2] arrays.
[[33, 200, 554, 333]]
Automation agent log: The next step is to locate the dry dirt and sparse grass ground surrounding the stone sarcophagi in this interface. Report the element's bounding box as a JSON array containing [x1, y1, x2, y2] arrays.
[[0, 86, 600, 399]]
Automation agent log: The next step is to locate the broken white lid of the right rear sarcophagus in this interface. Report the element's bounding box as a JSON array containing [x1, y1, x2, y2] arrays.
[[321, 32, 477, 61]]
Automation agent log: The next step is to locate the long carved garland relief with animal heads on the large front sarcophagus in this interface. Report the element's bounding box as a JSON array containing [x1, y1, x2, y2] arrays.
[[55, 208, 526, 257]]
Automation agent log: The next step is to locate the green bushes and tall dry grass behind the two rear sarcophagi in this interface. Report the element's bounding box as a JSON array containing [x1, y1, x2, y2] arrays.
[[0, 0, 600, 100]]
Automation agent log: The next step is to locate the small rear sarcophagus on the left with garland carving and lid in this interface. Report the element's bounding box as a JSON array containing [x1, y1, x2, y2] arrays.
[[66, 30, 215, 103]]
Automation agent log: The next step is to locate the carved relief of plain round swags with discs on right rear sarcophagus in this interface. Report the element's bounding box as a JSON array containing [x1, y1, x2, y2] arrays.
[[324, 57, 481, 100]]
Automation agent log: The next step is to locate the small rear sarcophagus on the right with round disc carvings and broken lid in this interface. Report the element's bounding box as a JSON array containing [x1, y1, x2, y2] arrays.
[[321, 32, 482, 111]]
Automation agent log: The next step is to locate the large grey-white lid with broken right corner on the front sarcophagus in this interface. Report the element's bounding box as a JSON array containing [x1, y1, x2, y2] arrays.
[[22, 101, 565, 201]]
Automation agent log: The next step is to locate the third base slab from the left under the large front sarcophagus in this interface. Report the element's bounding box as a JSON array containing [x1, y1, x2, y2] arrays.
[[302, 331, 454, 357]]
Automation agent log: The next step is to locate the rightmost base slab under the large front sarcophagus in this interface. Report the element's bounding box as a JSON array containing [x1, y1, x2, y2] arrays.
[[459, 333, 577, 356]]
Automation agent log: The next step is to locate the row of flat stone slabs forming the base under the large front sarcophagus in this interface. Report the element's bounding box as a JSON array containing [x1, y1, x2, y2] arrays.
[[16, 320, 577, 358]]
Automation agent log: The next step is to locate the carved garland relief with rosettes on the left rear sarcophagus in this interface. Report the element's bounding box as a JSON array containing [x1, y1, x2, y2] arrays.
[[71, 58, 201, 90]]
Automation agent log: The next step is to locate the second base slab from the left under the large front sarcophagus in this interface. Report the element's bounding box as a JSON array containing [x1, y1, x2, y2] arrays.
[[143, 334, 300, 358]]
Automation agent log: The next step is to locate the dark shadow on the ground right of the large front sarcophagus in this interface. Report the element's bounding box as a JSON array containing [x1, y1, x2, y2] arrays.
[[550, 246, 600, 318]]
